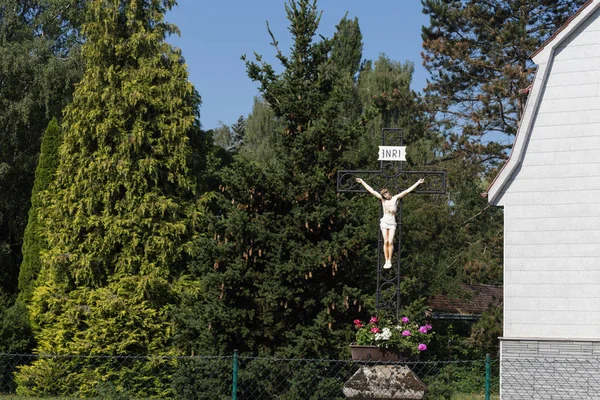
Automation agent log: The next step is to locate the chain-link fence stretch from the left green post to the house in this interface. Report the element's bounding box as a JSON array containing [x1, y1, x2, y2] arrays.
[[237, 357, 498, 400]]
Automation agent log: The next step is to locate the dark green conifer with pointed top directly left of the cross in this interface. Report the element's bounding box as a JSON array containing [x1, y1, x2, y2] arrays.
[[180, 0, 377, 357]]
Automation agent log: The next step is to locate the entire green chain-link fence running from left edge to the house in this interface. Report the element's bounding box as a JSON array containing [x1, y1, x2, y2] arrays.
[[0, 354, 499, 400]]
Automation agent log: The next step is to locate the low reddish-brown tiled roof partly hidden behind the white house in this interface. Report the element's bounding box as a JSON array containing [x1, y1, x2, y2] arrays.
[[429, 284, 503, 315]]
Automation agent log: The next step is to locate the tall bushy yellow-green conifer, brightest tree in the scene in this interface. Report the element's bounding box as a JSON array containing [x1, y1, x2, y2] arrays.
[[17, 0, 206, 397]]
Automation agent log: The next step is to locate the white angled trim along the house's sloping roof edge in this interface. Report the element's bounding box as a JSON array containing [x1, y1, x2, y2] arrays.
[[487, 0, 600, 205]]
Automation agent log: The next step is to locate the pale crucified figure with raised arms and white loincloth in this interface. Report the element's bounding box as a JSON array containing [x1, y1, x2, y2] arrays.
[[356, 178, 425, 269]]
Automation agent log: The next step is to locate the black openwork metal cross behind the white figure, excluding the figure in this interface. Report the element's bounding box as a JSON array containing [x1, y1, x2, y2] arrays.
[[337, 128, 446, 317]]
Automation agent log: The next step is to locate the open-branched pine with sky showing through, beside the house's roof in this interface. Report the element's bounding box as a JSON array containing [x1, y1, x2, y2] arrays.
[[422, 0, 585, 176]]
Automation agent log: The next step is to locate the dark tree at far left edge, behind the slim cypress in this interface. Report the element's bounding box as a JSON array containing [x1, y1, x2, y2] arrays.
[[0, 0, 83, 295]]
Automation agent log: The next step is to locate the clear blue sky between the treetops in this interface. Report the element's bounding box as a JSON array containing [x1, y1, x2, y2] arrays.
[[166, 0, 428, 129]]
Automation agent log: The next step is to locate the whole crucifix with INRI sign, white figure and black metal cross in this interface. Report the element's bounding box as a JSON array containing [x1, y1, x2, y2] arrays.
[[337, 128, 446, 316]]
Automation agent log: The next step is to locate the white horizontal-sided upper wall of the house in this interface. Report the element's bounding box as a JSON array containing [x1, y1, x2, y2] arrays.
[[499, 6, 600, 339]]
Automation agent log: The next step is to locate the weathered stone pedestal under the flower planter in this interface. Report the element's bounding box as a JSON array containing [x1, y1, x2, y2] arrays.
[[344, 365, 426, 400]]
